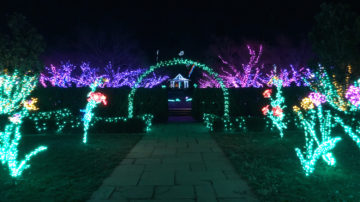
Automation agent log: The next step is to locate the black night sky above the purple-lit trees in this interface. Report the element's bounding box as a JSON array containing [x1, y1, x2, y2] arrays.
[[0, 0, 358, 63]]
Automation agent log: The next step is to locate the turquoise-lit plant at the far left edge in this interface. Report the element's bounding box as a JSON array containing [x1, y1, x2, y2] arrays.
[[0, 71, 47, 177]]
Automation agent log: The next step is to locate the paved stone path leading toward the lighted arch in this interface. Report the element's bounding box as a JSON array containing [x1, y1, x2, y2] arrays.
[[90, 123, 255, 202]]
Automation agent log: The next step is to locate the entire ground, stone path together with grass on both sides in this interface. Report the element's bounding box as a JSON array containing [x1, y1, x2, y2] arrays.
[[0, 123, 360, 202]]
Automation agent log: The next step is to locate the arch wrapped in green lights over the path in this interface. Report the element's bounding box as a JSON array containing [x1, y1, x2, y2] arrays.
[[128, 58, 230, 125]]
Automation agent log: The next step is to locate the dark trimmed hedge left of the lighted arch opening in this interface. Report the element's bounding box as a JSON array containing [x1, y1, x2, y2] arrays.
[[31, 87, 168, 122]]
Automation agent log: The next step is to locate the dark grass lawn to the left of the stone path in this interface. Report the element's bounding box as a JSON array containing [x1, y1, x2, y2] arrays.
[[0, 134, 142, 201]]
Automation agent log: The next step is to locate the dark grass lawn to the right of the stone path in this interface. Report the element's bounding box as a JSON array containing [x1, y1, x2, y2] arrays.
[[214, 131, 360, 201]]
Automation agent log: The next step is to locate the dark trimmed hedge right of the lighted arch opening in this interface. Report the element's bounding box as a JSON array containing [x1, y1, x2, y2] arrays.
[[192, 87, 309, 120]]
